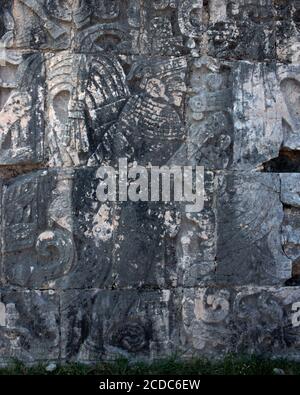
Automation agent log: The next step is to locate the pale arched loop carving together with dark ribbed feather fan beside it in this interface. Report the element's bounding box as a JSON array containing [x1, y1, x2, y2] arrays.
[[46, 52, 129, 167]]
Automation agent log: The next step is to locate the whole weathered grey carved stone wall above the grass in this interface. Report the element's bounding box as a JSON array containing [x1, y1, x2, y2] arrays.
[[0, 0, 300, 363]]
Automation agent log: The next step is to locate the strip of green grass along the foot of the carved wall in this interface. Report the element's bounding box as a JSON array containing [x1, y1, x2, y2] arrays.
[[0, 356, 300, 375]]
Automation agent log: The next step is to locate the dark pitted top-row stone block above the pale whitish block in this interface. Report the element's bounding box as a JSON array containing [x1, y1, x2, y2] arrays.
[[207, 0, 276, 62]]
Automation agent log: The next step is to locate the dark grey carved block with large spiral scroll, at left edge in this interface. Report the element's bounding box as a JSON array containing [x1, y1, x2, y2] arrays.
[[2, 170, 75, 288]]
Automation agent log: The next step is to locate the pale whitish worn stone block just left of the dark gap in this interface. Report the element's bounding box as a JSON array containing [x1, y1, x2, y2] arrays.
[[233, 63, 283, 169]]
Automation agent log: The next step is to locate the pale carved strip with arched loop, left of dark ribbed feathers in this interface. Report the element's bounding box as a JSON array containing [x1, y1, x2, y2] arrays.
[[46, 53, 88, 166]]
